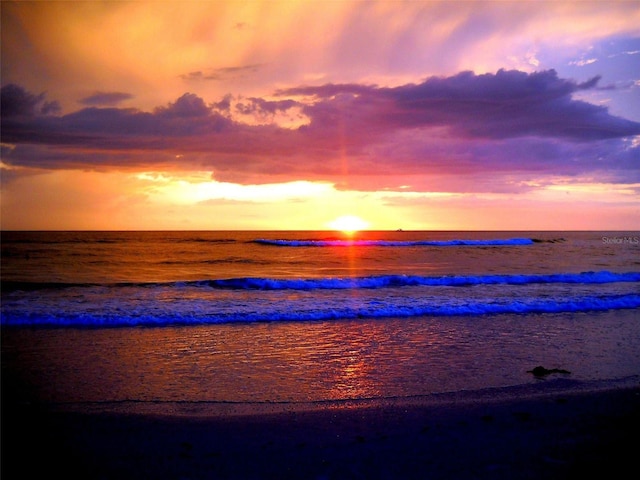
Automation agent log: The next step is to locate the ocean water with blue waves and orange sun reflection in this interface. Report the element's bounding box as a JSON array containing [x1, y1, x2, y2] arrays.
[[1, 231, 640, 411]]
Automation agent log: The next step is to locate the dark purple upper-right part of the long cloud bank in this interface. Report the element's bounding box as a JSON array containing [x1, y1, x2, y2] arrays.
[[278, 70, 640, 141]]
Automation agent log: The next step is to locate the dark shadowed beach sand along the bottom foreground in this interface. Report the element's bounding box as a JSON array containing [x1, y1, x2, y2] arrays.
[[2, 387, 640, 480]]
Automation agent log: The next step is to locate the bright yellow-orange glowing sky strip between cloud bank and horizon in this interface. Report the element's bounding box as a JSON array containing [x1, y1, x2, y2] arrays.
[[0, 167, 638, 231]]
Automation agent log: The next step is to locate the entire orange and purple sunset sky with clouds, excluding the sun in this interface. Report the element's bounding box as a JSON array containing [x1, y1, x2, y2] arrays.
[[0, 0, 640, 230]]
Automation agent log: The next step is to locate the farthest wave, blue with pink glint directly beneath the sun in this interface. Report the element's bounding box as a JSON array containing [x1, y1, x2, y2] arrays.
[[252, 238, 535, 247]]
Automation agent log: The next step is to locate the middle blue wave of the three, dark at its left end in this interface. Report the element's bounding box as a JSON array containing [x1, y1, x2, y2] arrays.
[[2, 271, 640, 292]]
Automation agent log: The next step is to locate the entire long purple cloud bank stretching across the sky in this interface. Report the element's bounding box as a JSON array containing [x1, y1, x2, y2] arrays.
[[2, 70, 640, 191]]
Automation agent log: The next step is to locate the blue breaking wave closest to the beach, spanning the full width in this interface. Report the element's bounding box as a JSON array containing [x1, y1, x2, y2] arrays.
[[1, 294, 640, 327]]
